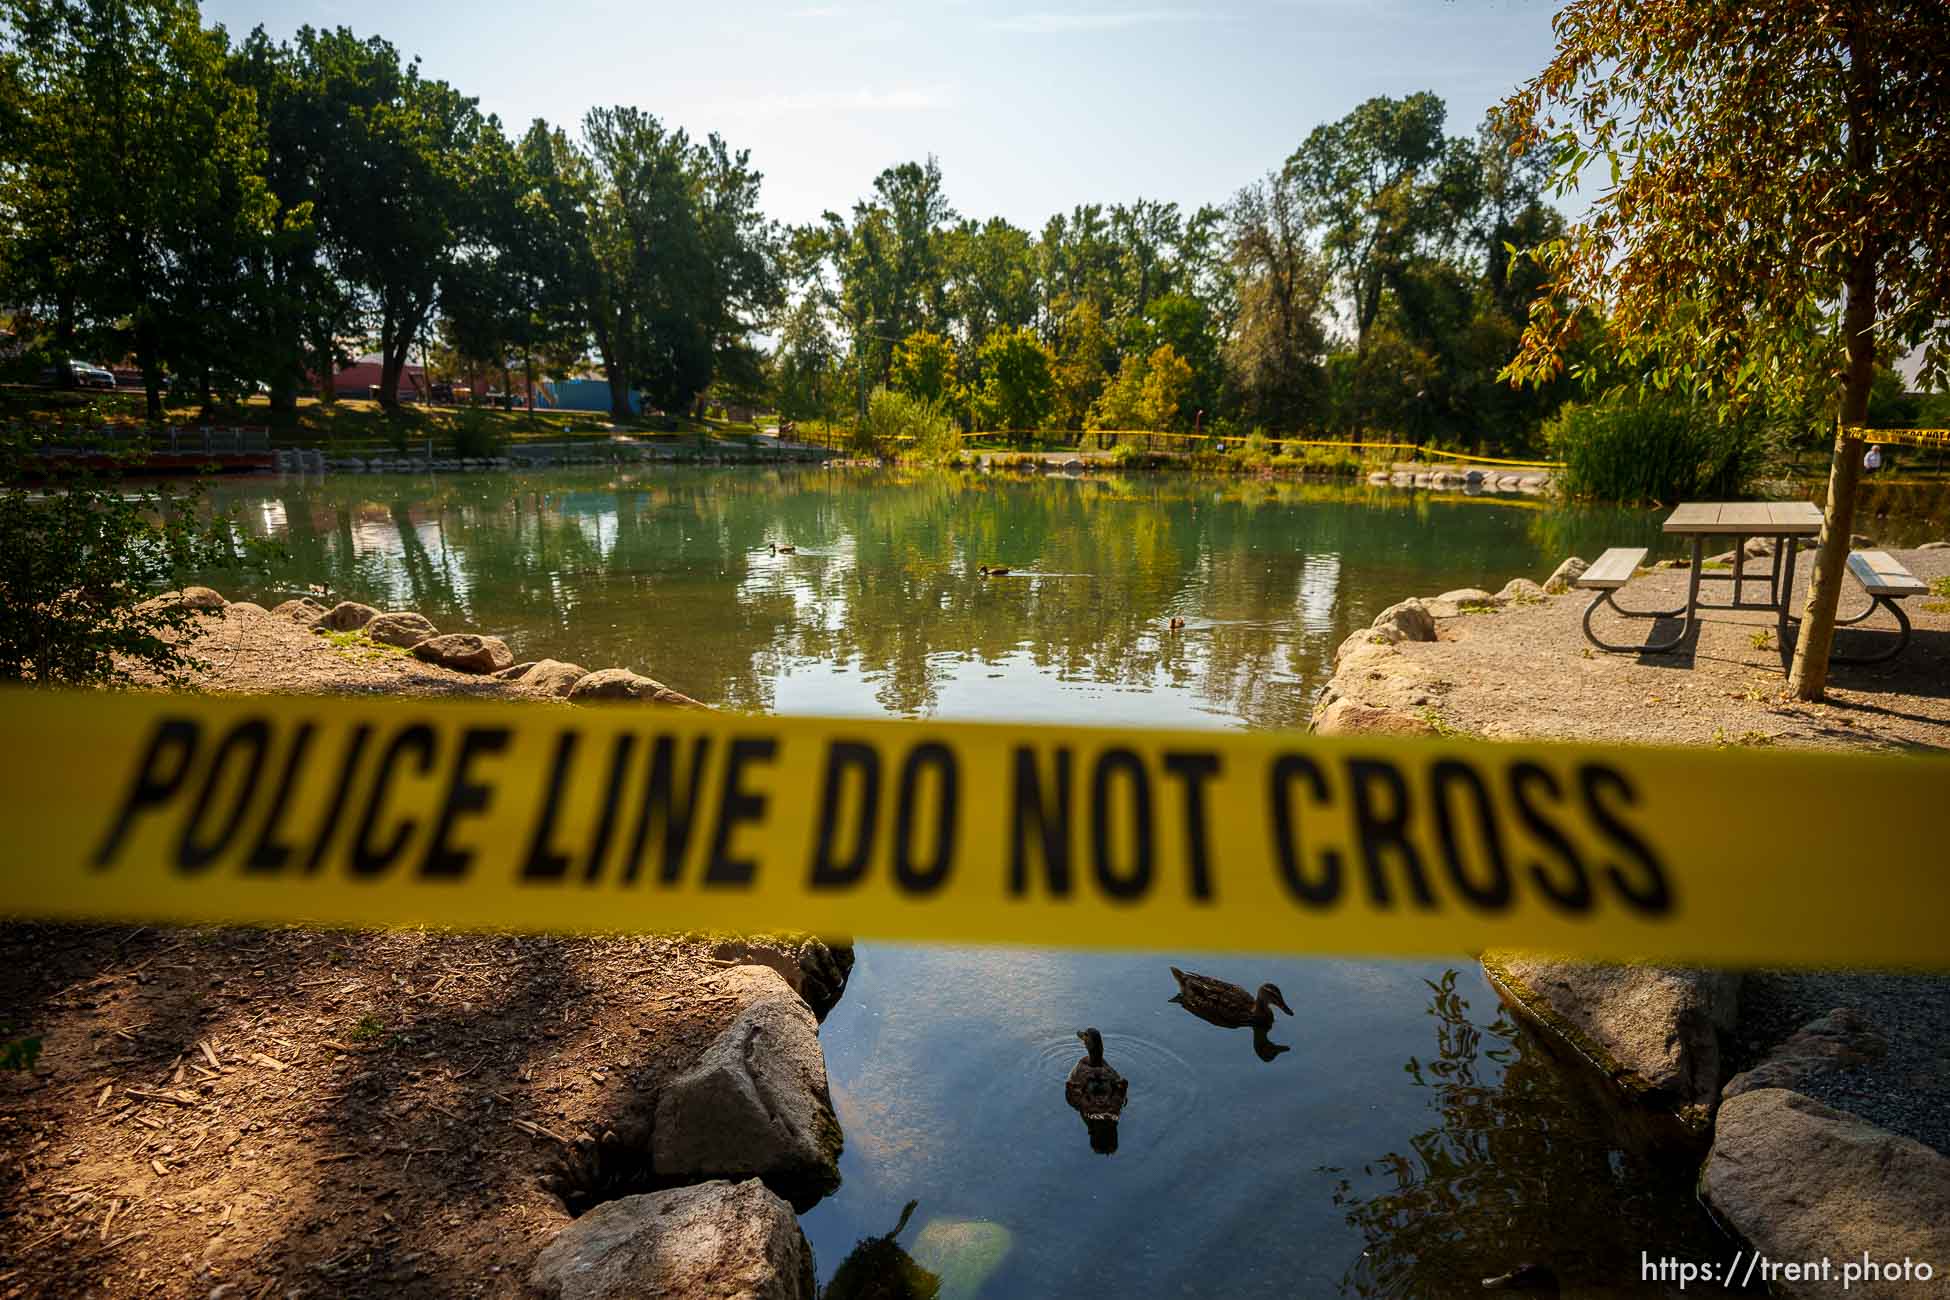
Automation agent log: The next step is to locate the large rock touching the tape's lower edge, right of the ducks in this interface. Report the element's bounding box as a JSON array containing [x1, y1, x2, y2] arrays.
[[1482, 951, 1739, 1136]]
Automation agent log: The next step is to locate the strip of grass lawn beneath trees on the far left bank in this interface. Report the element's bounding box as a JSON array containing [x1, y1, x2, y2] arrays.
[[0, 384, 776, 456]]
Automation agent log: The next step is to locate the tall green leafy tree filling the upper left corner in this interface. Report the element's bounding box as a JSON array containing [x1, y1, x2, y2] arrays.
[[0, 0, 271, 419]]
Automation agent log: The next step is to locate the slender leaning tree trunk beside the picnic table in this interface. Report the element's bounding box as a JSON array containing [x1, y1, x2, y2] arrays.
[[1788, 19, 1882, 700]]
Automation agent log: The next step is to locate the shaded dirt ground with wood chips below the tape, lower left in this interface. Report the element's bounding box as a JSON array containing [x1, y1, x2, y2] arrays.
[[0, 926, 760, 1300]]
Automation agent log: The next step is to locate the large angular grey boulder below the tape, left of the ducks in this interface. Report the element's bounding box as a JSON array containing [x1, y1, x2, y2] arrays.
[[653, 996, 840, 1214]]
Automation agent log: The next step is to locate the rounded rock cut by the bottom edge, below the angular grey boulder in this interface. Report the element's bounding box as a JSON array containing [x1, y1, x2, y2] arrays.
[[528, 1179, 815, 1300]]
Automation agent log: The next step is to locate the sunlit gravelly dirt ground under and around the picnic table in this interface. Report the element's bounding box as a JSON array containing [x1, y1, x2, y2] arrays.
[[1388, 550, 1950, 750]]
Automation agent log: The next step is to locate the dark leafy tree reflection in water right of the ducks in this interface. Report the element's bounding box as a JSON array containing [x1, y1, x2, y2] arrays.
[[1326, 971, 1726, 1300]]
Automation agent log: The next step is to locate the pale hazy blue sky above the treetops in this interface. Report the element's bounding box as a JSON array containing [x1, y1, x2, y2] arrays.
[[203, 0, 1554, 230]]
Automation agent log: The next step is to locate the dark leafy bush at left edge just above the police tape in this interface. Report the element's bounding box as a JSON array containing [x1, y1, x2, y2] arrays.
[[0, 433, 263, 686]]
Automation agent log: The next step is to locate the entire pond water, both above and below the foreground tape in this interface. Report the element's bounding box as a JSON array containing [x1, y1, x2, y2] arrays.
[[197, 470, 1794, 1298]]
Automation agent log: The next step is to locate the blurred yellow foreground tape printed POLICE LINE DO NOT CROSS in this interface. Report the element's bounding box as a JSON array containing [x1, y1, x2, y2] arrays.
[[0, 692, 1950, 967]]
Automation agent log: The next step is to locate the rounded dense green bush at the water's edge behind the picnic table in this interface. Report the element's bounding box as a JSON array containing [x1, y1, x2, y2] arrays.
[[1544, 390, 1765, 503]]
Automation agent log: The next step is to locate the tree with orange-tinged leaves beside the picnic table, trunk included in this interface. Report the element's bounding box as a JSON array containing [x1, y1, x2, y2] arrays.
[[1502, 0, 1950, 700]]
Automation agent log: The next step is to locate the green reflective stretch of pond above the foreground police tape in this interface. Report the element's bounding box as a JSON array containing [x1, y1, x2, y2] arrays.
[[197, 468, 1684, 727]]
